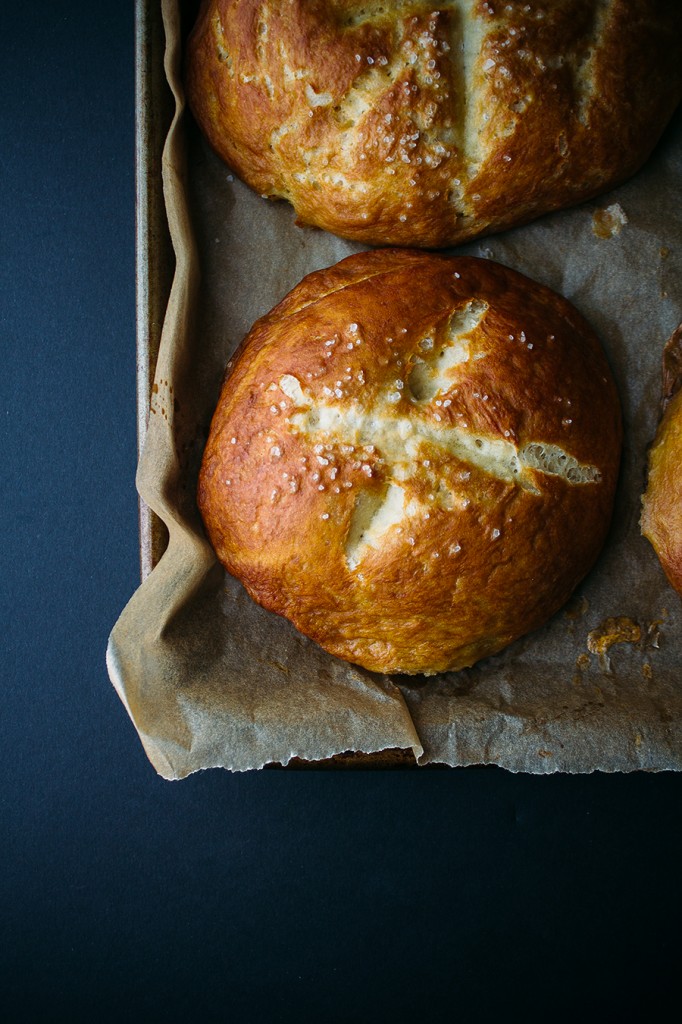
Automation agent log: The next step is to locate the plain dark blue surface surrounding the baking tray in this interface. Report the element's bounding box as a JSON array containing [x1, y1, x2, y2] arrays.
[[0, 0, 682, 1022]]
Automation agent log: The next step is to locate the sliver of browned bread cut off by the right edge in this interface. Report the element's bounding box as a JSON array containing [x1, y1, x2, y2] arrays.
[[641, 324, 682, 595]]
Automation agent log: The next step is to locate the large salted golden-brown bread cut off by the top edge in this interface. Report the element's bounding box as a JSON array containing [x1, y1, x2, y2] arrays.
[[186, 0, 682, 247]]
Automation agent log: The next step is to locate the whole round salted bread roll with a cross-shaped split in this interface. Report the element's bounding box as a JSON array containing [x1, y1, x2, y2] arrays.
[[199, 250, 621, 673]]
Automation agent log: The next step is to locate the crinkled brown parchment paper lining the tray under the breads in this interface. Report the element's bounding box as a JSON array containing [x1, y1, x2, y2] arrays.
[[103, 0, 682, 778]]
